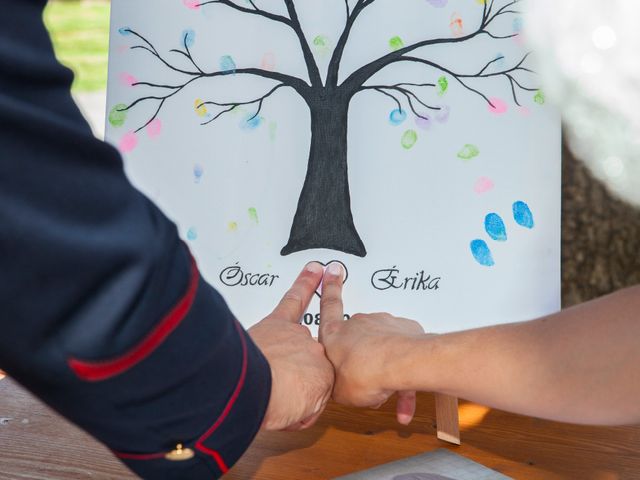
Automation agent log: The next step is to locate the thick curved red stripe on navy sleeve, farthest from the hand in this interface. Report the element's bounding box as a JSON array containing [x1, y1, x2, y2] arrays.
[[67, 257, 200, 382]]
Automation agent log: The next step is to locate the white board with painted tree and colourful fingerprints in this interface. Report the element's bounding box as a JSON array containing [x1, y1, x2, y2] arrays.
[[106, 0, 561, 333]]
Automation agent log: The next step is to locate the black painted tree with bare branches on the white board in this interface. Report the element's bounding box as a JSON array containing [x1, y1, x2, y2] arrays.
[[122, 0, 537, 257]]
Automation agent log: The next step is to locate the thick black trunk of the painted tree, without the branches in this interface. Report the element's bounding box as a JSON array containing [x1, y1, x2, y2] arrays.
[[280, 95, 367, 257]]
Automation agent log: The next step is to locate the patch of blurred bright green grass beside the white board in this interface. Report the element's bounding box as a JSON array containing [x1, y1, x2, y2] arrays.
[[44, 0, 110, 93]]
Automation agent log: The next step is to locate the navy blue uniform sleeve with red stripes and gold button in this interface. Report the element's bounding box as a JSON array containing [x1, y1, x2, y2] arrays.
[[0, 0, 271, 480]]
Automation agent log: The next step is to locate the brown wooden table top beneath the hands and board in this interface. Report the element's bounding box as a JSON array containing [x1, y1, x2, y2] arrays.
[[0, 379, 640, 480]]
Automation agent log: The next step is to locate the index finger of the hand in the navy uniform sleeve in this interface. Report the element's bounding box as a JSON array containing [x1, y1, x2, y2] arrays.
[[270, 262, 323, 323]]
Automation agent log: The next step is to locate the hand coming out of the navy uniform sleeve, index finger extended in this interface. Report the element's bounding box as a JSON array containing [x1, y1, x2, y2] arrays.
[[249, 263, 334, 430]]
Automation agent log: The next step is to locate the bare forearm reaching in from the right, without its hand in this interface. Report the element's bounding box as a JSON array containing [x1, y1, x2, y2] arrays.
[[388, 287, 640, 424]]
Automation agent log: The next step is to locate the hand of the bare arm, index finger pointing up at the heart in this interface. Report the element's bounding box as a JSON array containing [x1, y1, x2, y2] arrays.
[[320, 263, 424, 425]]
